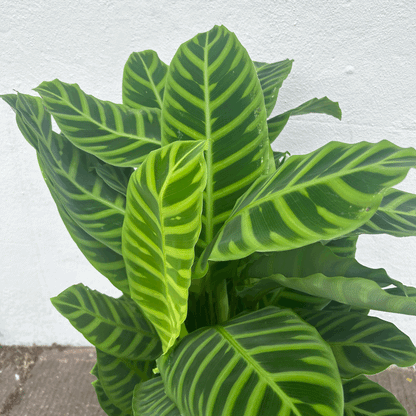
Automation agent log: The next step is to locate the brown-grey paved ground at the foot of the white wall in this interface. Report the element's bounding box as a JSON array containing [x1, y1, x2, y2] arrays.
[[0, 345, 416, 416]]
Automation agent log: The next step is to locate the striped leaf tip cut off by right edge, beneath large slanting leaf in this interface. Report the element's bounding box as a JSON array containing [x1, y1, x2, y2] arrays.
[[352, 189, 416, 237]]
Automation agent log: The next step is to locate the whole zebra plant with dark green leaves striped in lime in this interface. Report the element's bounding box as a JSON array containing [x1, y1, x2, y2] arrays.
[[2, 27, 416, 416]]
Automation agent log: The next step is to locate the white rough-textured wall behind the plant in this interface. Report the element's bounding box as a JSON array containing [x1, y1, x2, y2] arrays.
[[0, 0, 416, 345]]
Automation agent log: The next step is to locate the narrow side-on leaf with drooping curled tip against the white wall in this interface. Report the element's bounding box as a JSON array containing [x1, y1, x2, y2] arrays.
[[267, 97, 341, 143]]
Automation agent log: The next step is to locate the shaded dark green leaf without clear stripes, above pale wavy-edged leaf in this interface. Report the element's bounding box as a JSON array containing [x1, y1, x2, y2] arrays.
[[242, 243, 406, 297]]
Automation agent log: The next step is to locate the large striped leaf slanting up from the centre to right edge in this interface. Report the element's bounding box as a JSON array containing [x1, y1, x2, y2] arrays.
[[198, 141, 416, 275]]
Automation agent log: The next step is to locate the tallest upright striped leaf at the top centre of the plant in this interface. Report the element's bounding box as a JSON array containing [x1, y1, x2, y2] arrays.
[[162, 26, 270, 254]]
